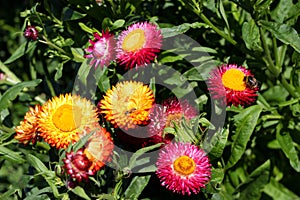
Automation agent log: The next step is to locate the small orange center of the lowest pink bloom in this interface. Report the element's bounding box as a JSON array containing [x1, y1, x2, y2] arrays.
[[173, 155, 196, 176]]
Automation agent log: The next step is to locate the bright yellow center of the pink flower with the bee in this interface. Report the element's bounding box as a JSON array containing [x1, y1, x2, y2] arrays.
[[222, 69, 246, 91]]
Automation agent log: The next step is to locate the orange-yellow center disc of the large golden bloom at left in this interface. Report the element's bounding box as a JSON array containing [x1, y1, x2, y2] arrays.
[[52, 104, 81, 132]]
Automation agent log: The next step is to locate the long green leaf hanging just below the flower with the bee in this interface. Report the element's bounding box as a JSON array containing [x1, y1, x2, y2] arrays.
[[226, 105, 262, 168]]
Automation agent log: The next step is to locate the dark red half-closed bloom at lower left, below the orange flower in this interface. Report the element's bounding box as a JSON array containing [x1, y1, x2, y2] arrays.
[[63, 149, 95, 182]]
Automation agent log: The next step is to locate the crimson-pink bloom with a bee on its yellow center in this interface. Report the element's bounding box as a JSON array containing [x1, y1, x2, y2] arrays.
[[207, 64, 259, 106]]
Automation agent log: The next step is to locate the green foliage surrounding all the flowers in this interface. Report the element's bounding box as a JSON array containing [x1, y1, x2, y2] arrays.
[[0, 0, 300, 200]]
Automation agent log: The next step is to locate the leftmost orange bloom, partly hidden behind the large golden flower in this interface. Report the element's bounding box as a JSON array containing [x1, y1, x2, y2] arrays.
[[15, 105, 41, 144]]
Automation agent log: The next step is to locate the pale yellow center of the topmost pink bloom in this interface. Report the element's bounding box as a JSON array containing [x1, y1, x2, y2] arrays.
[[122, 29, 146, 52]]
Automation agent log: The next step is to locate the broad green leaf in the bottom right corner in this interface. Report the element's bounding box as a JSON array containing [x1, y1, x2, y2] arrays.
[[263, 178, 300, 200]]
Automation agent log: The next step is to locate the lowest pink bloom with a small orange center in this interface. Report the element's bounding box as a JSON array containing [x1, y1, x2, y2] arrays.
[[156, 142, 211, 195]]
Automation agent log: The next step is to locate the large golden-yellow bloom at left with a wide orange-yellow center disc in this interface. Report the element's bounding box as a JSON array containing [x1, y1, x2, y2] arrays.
[[38, 94, 99, 148]]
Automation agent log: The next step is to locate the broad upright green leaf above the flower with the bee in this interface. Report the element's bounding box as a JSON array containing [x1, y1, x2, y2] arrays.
[[242, 19, 263, 51]]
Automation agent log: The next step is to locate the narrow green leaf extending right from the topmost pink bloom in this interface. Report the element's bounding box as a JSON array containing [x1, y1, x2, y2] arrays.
[[161, 22, 208, 38]]
